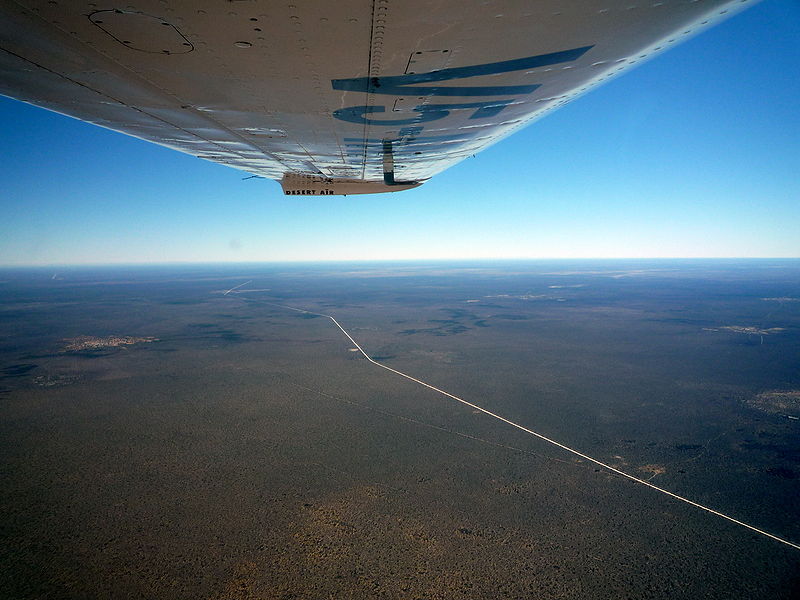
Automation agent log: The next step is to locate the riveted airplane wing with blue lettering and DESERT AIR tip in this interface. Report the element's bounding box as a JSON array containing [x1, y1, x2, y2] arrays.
[[0, 0, 757, 195]]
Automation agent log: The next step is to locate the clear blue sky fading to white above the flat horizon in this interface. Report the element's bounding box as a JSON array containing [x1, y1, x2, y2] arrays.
[[0, 0, 800, 266]]
